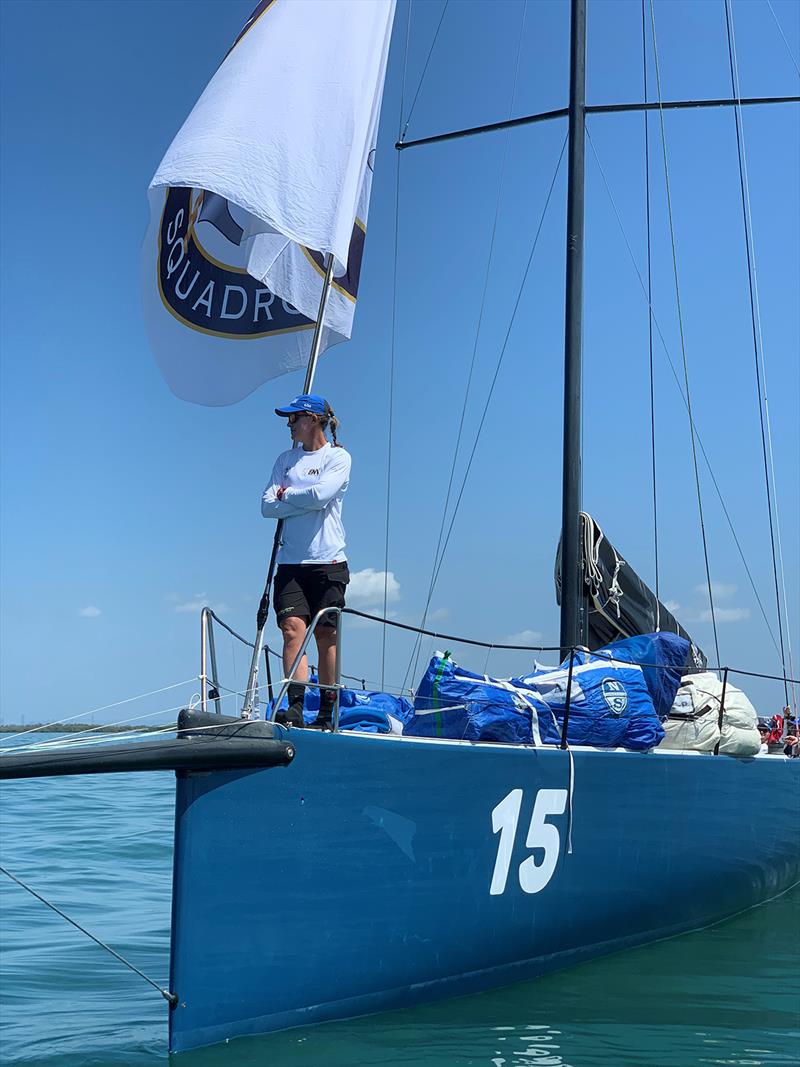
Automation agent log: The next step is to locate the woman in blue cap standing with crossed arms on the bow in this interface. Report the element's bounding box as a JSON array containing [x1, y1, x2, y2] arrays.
[[261, 394, 351, 729]]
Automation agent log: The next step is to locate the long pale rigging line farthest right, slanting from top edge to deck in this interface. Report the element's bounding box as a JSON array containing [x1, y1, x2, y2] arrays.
[[724, 0, 797, 705]]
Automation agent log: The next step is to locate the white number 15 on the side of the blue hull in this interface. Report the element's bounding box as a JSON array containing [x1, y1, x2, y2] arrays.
[[489, 790, 566, 896]]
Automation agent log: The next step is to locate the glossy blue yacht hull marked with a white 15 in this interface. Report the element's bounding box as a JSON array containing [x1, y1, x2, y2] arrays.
[[170, 731, 800, 1051]]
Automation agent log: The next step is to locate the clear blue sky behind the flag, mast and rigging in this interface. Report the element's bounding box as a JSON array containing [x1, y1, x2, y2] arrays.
[[0, 0, 800, 722]]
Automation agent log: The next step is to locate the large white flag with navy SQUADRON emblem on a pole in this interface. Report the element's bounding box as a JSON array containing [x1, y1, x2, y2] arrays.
[[143, 0, 395, 404]]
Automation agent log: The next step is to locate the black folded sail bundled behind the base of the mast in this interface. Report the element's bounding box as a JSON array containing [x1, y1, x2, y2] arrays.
[[556, 511, 706, 670]]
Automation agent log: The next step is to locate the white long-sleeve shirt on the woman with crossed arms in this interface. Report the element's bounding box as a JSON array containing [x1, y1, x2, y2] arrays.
[[261, 444, 351, 563]]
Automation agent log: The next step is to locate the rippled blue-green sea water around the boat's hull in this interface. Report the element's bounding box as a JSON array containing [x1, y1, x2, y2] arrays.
[[0, 738, 800, 1067]]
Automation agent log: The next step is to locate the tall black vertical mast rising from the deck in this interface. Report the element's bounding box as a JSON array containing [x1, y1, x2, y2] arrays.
[[560, 0, 586, 654]]
